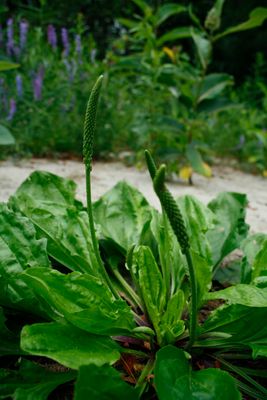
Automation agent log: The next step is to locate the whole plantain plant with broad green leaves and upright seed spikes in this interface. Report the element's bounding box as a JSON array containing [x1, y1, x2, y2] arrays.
[[0, 77, 267, 400]]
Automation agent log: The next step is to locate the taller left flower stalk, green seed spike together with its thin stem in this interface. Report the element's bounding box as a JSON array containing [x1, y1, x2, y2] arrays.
[[83, 75, 118, 297]]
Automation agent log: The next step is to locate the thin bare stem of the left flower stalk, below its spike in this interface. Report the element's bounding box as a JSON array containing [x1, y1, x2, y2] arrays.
[[85, 165, 119, 298]]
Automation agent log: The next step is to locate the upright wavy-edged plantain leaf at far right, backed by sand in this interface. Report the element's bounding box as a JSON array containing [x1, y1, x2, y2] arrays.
[[207, 192, 248, 265]]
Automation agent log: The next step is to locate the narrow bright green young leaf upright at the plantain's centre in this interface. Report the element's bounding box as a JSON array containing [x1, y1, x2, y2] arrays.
[[132, 246, 166, 343]]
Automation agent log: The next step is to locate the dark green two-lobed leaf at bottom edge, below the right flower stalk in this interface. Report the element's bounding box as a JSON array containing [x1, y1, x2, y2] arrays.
[[155, 346, 241, 400]]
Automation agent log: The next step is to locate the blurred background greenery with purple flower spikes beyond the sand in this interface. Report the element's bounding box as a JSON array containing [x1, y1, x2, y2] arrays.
[[0, 0, 267, 179]]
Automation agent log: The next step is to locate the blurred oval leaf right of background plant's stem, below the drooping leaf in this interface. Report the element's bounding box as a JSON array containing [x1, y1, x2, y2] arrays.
[[198, 74, 233, 103]]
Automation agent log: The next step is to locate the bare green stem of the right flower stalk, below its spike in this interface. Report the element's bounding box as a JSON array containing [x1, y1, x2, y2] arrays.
[[185, 249, 197, 349]]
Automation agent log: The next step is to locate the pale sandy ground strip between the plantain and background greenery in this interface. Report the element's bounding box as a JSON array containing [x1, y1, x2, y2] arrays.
[[0, 159, 267, 233]]
